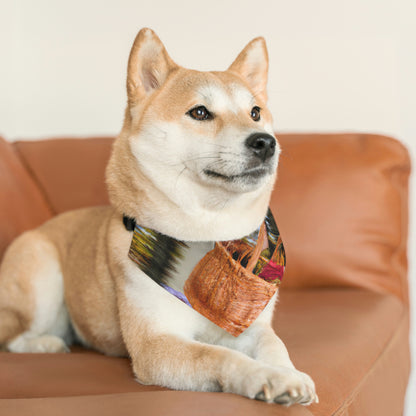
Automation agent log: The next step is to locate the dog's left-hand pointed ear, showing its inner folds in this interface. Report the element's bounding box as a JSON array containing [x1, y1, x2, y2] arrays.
[[127, 28, 178, 104]]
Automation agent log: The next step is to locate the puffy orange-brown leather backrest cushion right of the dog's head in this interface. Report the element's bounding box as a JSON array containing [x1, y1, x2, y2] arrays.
[[271, 134, 410, 302]]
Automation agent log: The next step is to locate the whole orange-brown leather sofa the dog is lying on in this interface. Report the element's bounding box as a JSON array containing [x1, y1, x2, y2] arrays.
[[0, 134, 410, 416]]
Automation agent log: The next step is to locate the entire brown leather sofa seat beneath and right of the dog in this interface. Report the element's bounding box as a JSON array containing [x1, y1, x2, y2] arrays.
[[0, 289, 409, 416]]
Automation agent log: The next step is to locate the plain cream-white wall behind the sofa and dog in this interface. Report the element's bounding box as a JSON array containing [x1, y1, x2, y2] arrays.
[[0, 0, 416, 416]]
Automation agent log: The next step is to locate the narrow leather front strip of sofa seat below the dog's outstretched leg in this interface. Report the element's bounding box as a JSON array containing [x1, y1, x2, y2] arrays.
[[0, 391, 312, 416]]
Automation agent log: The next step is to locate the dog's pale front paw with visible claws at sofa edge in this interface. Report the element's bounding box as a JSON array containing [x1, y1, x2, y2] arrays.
[[229, 367, 318, 406]]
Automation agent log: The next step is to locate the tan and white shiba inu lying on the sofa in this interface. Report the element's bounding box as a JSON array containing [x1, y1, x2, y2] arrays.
[[0, 29, 318, 405]]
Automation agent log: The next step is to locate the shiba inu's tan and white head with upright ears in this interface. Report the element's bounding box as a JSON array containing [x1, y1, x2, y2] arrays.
[[107, 29, 280, 239]]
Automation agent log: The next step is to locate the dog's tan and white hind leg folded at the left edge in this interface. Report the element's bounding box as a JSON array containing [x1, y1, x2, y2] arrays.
[[0, 231, 69, 352]]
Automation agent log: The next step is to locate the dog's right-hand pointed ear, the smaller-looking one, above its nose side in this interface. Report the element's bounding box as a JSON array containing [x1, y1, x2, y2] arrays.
[[228, 37, 269, 101]]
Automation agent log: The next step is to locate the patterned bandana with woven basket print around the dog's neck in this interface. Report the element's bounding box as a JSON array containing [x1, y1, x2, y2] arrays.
[[127, 209, 286, 336]]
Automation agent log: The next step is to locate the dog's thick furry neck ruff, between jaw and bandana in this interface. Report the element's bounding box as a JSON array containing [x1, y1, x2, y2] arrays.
[[107, 138, 273, 241]]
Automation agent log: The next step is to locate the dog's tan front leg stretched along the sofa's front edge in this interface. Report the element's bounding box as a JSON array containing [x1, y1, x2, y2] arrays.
[[119, 292, 315, 404]]
